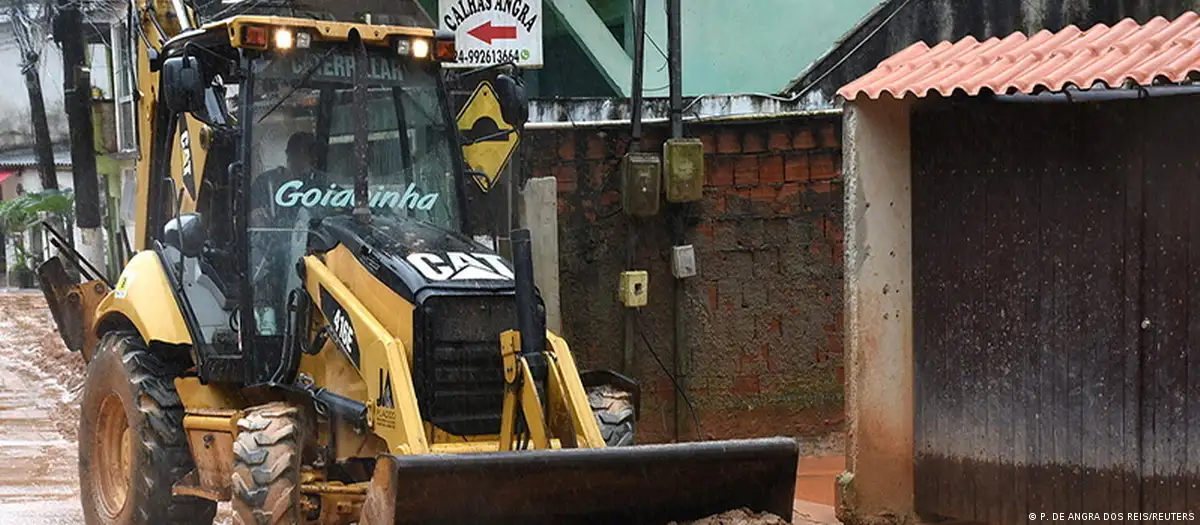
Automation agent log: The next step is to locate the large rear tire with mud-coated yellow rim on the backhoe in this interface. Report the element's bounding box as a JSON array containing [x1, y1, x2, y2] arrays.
[[79, 332, 216, 525]]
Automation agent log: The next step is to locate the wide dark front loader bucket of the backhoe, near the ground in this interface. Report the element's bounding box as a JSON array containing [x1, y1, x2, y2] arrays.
[[362, 438, 799, 525]]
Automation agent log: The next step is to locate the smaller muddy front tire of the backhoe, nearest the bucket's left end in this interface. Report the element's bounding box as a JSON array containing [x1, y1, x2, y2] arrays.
[[233, 403, 304, 525]]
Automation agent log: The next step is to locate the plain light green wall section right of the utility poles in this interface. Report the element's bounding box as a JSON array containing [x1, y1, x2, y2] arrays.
[[681, 0, 880, 95]]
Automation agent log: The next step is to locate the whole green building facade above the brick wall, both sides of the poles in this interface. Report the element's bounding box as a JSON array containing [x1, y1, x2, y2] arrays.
[[421, 0, 881, 97]]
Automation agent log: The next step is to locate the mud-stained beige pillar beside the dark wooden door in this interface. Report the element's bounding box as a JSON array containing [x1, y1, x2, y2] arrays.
[[838, 95, 914, 524]]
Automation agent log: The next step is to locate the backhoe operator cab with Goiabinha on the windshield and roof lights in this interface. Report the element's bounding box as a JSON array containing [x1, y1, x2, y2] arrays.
[[145, 17, 527, 385]]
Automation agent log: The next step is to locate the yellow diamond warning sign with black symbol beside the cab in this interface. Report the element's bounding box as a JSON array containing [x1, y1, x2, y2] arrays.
[[458, 80, 521, 193]]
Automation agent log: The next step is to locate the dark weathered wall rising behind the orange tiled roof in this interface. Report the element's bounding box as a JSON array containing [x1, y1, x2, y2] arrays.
[[788, 0, 1200, 108]]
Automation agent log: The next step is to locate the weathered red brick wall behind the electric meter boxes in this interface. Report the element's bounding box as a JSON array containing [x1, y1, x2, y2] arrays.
[[523, 117, 842, 442]]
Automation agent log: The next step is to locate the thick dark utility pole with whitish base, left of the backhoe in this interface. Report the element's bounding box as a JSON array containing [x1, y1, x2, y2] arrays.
[[54, 0, 104, 266]]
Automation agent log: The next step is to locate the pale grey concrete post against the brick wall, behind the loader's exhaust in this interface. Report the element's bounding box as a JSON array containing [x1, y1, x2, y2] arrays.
[[518, 177, 563, 334]]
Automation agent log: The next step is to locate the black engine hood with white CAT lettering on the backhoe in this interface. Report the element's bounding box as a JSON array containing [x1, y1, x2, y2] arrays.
[[311, 217, 515, 304]]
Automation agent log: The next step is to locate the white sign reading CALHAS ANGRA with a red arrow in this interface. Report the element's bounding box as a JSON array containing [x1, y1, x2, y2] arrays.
[[438, 0, 542, 67]]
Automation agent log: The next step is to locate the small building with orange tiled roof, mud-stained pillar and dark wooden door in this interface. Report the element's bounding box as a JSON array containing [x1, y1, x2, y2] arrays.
[[835, 6, 1200, 524]]
